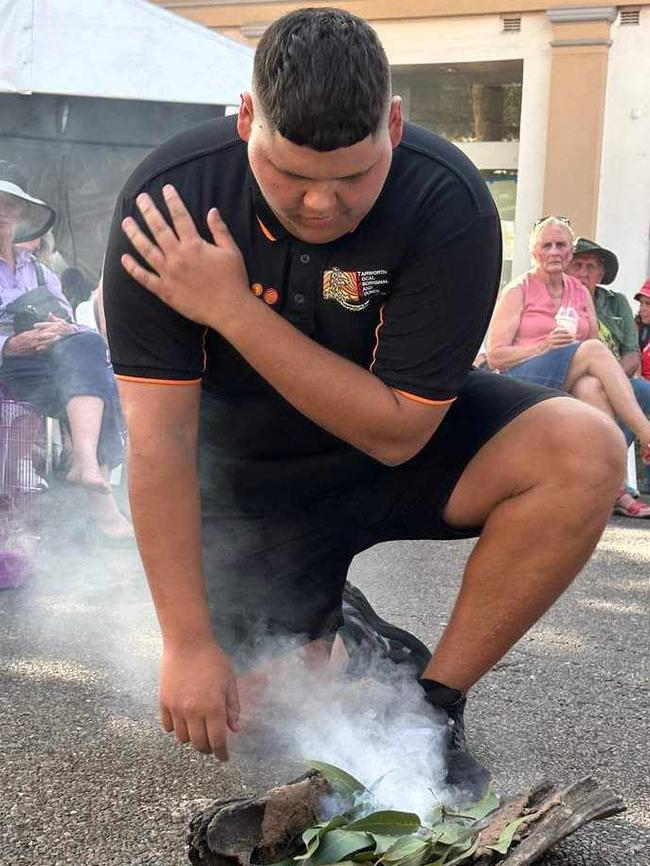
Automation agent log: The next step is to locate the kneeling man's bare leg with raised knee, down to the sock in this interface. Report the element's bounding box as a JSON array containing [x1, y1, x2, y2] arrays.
[[423, 397, 625, 692]]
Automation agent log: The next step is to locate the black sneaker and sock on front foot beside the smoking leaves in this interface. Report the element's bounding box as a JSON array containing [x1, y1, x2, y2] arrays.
[[420, 680, 491, 802]]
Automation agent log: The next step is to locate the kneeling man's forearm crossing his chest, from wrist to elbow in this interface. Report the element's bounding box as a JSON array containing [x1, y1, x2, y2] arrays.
[[215, 295, 442, 464]]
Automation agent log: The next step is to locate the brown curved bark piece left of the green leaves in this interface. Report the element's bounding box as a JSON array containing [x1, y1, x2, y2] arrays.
[[188, 771, 333, 866]]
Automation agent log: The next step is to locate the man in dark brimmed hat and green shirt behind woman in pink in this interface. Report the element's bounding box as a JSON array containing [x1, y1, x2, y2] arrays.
[[567, 238, 650, 517]]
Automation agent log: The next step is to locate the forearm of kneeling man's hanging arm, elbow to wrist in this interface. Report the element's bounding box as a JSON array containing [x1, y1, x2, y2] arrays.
[[128, 443, 212, 646]]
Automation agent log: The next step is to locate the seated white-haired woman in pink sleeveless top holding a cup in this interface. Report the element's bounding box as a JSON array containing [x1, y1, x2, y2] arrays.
[[486, 217, 650, 516]]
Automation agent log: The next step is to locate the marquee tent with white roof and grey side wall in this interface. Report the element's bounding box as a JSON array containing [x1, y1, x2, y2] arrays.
[[0, 0, 253, 280]]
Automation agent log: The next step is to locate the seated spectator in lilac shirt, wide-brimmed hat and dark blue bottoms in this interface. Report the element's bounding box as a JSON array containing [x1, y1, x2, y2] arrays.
[[0, 162, 133, 539]]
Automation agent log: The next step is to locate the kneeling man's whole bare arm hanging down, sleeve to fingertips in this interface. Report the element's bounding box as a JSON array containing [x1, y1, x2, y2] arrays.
[[119, 380, 238, 759]]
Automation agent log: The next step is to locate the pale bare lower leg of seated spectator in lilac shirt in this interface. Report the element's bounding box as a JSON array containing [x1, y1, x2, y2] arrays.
[[65, 396, 110, 493]]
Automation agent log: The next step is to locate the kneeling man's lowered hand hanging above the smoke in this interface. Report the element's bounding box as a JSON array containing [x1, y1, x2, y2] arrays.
[[160, 640, 239, 761]]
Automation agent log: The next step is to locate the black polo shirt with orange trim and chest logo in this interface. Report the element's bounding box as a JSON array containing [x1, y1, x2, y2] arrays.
[[104, 117, 501, 506]]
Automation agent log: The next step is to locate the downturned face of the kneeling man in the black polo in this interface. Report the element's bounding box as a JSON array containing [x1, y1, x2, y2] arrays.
[[237, 93, 402, 244]]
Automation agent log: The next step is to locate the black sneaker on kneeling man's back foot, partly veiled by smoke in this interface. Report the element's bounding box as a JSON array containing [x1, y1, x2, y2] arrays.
[[338, 582, 431, 677]]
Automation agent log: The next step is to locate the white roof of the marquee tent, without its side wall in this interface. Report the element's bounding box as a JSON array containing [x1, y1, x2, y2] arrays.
[[0, 0, 253, 105]]
